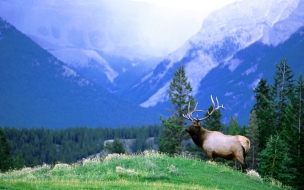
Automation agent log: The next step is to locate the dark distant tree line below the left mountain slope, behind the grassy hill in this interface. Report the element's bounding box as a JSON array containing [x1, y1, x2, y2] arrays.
[[0, 125, 162, 171]]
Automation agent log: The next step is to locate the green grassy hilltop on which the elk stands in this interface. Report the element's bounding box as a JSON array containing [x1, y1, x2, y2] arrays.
[[0, 151, 288, 190]]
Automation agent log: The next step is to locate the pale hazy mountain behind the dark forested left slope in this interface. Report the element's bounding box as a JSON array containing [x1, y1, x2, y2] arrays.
[[0, 0, 160, 97]]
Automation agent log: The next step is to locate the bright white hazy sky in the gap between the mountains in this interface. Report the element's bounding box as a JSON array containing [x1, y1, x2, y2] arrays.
[[128, 0, 236, 55]]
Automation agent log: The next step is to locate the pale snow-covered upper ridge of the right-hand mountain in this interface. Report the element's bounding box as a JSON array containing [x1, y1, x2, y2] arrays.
[[137, 0, 304, 107]]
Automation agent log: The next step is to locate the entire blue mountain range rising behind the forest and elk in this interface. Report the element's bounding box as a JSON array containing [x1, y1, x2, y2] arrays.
[[0, 0, 304, 127]]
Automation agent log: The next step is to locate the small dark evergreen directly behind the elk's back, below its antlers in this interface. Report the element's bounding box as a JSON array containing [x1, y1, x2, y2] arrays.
[[202, 106, 224, 131]]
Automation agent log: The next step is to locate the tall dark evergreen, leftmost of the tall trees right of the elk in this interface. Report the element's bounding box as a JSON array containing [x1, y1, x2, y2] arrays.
[[253, 78, 276, 150]]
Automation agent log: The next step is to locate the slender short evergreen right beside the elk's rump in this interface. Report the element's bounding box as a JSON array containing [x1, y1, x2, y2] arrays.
[[246, 110, 260, 169]]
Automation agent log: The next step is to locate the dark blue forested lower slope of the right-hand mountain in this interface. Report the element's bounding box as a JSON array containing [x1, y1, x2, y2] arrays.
[[137, 27, 304, 125]]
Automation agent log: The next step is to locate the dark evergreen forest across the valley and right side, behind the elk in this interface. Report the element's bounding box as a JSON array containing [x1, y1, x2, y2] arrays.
[[0, 59, 304, 189]]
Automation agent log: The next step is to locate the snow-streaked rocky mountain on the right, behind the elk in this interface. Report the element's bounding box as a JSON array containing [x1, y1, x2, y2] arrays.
[[124, 0, 304, 124]]
